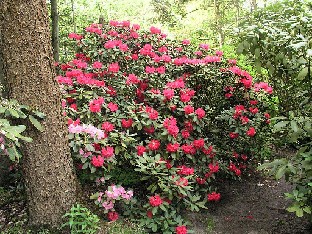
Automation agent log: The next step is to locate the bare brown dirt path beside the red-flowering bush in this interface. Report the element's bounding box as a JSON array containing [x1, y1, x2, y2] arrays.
[[192, 173, 312, 234]]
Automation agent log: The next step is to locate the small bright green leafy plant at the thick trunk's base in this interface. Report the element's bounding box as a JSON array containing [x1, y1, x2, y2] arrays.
[[62, 204, 100, 234]]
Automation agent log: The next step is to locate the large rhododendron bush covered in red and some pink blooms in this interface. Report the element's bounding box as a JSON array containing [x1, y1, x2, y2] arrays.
[[57, 21, 272, 233]]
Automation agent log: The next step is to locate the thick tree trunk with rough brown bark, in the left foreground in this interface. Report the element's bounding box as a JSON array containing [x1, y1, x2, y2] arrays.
[[0, 0, 76, 227]]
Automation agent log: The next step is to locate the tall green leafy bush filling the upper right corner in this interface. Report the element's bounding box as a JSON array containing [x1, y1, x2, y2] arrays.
[[237, 0, 312, 115]]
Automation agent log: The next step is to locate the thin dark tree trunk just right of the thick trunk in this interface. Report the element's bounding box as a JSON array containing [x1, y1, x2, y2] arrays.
[[51, 0, 60, 62]]
